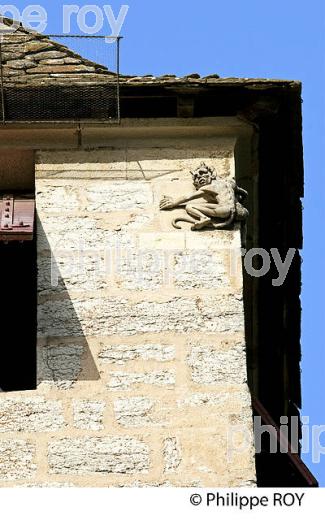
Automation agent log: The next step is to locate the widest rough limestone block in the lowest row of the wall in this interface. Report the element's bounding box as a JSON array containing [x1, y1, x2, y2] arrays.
[[48, 436, 150, 475]]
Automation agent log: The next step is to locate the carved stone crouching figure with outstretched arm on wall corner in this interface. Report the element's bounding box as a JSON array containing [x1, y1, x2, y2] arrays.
[[160, 163, 248, 231]]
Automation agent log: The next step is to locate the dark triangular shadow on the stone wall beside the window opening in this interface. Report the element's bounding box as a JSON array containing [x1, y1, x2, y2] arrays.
[[37, 219, 100, 388]]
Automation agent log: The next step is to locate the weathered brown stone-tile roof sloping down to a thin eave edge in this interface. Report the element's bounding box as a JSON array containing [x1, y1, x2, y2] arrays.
[[1, 19, 299, 89]]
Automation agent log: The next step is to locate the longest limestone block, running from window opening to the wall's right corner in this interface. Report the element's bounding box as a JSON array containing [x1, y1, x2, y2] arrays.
[[38, 294, 244, 337]]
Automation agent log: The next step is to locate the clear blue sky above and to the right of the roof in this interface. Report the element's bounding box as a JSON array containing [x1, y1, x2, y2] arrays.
[[1, 0, 325, 486]]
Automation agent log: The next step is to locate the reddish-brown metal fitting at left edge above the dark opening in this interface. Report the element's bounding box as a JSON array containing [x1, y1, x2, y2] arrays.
[[0, 195, 35, 242]]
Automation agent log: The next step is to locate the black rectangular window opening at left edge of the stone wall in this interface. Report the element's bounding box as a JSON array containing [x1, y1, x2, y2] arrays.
[[0, 199, 37, 392]]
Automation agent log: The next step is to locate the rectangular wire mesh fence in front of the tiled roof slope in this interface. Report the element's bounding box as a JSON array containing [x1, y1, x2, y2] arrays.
[[0, 31, 120, 123]]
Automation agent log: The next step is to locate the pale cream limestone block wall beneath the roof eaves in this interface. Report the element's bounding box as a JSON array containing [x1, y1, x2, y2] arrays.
[[0, 132, 255, 486]]
